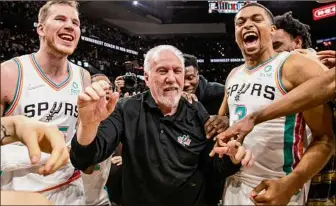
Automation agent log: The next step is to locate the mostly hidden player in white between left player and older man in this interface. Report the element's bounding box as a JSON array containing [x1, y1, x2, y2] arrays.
[[82, 74, 112, 205]]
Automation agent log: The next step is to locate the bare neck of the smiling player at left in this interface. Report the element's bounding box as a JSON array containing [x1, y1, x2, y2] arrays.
[[35, 48, 68, 76]]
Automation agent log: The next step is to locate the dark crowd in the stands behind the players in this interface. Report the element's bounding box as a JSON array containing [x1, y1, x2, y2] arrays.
[[0, 1, 251, 83]]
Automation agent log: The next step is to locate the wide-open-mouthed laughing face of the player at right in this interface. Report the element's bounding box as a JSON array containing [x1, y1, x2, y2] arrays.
[[235, 6, 275, 56]]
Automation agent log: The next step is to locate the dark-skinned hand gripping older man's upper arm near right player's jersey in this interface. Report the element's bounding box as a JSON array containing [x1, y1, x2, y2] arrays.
[[204, 115, 229, 139]]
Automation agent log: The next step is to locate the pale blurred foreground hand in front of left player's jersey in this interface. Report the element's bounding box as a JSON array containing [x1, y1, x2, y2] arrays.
[[7, 116, 69, 175]]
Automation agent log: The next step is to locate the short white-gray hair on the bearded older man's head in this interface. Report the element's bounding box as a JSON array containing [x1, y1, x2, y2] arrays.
[[144, 45, 184, 72]]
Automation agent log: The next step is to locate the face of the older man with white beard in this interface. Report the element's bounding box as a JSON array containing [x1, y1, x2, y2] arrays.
[[145, 50, 184, 108]]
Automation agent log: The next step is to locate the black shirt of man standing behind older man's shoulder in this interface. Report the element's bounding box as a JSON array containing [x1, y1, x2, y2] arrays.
[[195, 75, 225, 115]]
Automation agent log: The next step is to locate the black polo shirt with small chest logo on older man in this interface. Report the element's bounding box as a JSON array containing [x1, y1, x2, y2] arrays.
[[70, 91, 239, 205]]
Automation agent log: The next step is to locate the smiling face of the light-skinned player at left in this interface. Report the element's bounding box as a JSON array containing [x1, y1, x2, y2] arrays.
[[37, 4, 80, 55]]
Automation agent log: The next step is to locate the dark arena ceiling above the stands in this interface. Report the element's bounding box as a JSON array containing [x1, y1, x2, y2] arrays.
[[80, 1, 336, 38]]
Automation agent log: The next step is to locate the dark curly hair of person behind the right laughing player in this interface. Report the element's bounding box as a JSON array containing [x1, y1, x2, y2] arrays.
[[274, 11, 312, 49]]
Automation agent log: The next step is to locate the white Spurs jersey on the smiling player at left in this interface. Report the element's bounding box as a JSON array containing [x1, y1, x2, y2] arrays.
[[1, 54, 84, 191]]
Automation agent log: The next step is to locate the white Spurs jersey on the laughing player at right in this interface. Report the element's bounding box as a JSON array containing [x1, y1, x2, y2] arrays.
[[226, 52, 305, 187]]
